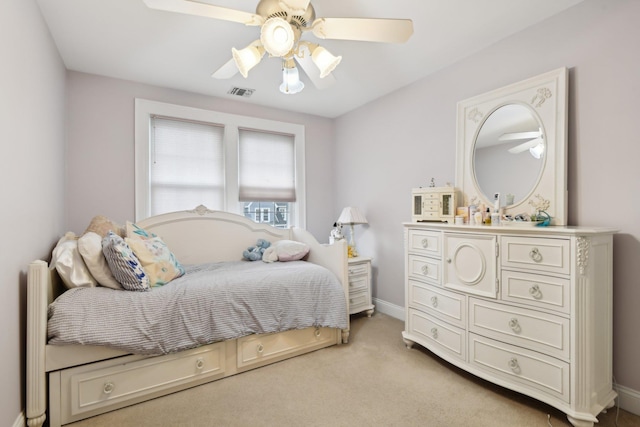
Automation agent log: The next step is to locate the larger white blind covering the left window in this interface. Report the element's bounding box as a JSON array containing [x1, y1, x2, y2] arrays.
[[149, 116, 225, 215]]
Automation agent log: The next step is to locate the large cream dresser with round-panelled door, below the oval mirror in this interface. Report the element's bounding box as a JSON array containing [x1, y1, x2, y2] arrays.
[[403, 223, 616, 426]]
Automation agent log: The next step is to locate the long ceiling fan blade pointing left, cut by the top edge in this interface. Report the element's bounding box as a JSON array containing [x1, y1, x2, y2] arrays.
[[142, 0, 264, 25]]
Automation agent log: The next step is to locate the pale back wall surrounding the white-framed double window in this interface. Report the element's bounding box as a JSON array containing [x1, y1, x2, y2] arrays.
[[66, 72, 337, 242]]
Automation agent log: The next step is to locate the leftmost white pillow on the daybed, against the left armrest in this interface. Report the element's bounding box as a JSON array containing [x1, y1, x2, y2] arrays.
[[51, 231, 96, 289]]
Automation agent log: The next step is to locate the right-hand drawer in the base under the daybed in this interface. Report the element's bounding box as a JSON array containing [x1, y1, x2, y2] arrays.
[[237, 328, 336, 369]]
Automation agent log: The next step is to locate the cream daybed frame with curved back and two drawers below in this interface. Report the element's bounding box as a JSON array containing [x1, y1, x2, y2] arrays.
[[26, 206, 349, 427]]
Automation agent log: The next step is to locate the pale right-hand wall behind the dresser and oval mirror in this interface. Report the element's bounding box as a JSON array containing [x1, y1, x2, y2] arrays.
[[336, 0, 640, 404]]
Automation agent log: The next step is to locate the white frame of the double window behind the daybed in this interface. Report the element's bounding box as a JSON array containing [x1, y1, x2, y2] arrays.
[[134, 98, 306, 228]]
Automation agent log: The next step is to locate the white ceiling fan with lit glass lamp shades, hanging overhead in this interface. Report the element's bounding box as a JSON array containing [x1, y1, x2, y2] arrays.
[[143, 0, 413, 94]]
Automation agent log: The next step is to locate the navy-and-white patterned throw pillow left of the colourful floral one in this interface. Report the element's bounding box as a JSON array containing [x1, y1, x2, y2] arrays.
[[102, 231, 151, 291]]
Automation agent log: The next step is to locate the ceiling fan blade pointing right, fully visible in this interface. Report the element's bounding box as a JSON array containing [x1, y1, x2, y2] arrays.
[[311, 18, 413, 43]]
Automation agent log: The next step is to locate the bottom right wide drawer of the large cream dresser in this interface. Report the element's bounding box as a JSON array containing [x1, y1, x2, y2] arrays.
[[469, 334, 570, 402]]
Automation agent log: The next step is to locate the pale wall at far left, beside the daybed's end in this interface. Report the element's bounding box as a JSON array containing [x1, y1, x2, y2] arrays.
[[0, 0, 65, 426]]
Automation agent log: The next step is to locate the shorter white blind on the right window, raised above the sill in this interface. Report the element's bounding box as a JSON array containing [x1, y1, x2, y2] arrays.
[[238, 129, 296, 202]]
